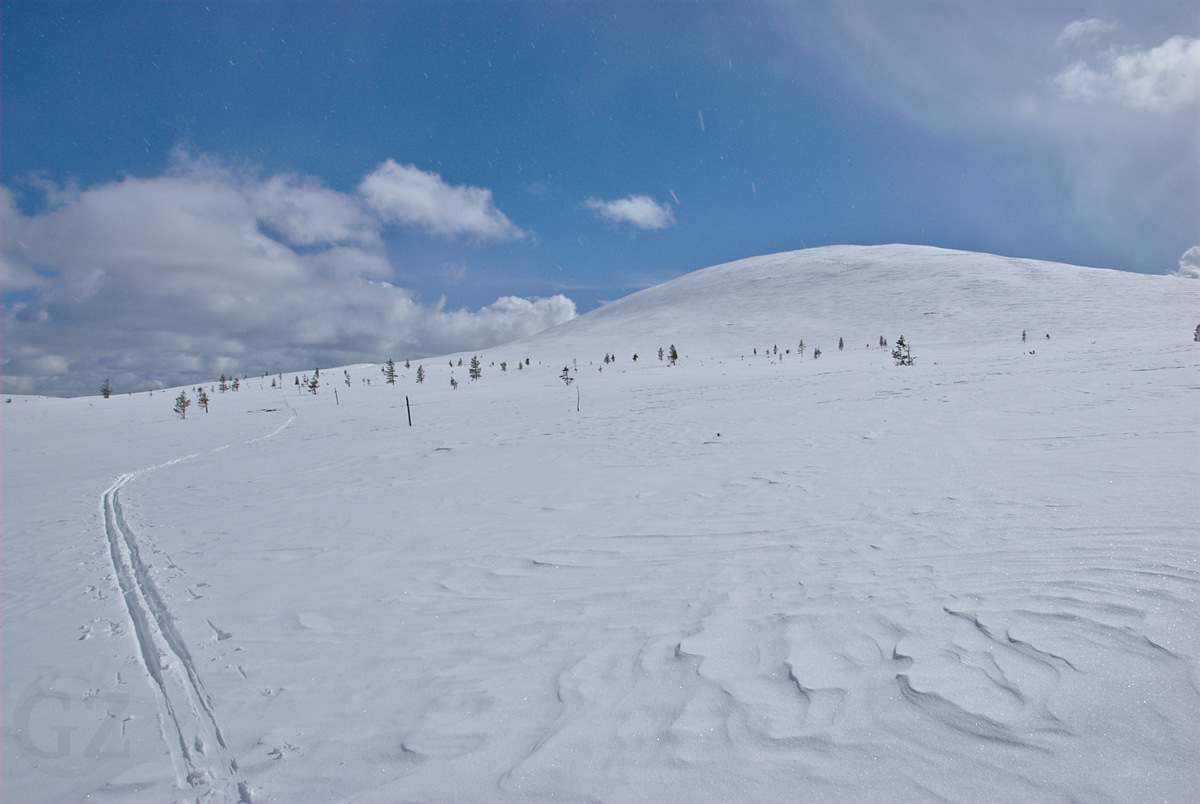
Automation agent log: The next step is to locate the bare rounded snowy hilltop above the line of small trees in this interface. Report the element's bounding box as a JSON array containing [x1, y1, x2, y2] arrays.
[[529, 245, 1200, 356]]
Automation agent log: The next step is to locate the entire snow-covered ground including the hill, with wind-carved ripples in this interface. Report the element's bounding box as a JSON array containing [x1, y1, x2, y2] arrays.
[[7, 246, 1200, 802]]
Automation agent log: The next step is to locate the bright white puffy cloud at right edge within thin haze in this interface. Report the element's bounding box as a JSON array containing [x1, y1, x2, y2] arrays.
[[1054, 36, 1200, 113]]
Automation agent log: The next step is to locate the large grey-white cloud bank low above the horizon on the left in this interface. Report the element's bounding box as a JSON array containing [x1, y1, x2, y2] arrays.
[[0, 157, 576, 395]]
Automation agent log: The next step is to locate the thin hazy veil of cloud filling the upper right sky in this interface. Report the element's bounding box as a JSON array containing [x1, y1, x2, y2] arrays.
[[776, 2, 1200, 270]]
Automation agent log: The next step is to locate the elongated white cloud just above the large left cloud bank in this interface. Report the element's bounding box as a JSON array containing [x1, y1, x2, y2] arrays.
[[359, 160, 526, 240]]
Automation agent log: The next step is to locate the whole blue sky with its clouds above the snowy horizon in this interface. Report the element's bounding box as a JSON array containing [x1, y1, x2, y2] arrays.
[[0, 0, 1200, 394]]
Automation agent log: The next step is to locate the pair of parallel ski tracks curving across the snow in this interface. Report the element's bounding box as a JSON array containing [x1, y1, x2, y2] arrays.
[[101, 398, 296, 804]]
